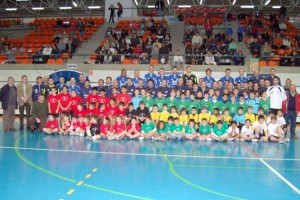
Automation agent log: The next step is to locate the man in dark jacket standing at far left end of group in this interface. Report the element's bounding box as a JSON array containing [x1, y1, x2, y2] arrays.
[[0, 77, 17, 132]]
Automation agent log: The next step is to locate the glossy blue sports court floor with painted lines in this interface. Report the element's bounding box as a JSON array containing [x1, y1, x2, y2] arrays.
[[0, 122, 300, 200]]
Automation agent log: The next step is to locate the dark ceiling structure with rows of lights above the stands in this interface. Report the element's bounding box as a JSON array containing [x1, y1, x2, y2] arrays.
[[0, 0, 300, 18]]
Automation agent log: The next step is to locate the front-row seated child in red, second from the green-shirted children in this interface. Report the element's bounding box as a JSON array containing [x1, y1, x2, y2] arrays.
[[107, 115, 127, 140]]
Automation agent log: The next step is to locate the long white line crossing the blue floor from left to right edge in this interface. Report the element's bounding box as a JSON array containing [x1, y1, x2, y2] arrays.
[[0, 146, 300, 161]]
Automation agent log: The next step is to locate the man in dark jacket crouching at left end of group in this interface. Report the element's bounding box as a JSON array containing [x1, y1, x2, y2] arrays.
[[29, 94, 48, 132]]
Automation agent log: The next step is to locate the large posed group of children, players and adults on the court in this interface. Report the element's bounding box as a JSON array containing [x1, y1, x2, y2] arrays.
[[0, 65, 300, 143]]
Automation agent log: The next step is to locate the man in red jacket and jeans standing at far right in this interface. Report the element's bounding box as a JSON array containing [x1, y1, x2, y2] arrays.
[[283, 84, 300, 139]]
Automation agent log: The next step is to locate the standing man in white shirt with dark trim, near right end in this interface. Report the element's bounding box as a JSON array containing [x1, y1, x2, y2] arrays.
[[267, 77, 286, 115]]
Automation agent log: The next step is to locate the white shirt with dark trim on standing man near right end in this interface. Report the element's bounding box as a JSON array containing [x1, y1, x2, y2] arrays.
[[267, 85, 286, 109]]
